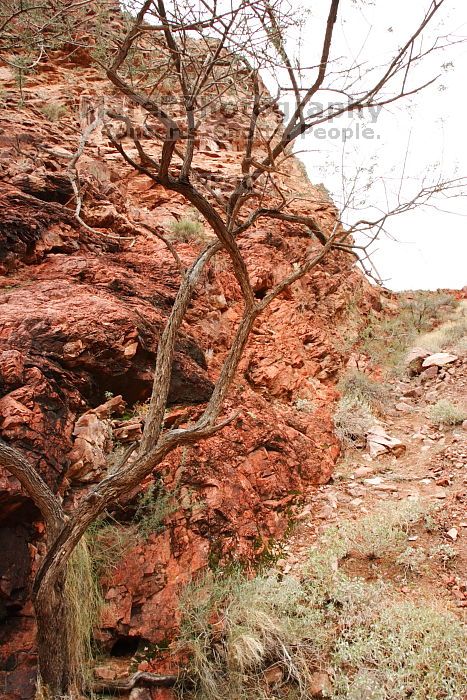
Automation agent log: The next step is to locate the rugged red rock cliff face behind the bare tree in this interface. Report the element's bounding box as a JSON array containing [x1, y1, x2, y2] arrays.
[[0, 34, 378, 700]]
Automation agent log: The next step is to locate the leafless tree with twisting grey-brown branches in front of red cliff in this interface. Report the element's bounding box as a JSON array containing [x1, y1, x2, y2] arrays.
[[0, 0, 466, 697]]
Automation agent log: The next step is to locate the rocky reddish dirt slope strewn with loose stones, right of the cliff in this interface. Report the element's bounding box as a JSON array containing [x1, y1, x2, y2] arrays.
[[278, 322, 467, 613]]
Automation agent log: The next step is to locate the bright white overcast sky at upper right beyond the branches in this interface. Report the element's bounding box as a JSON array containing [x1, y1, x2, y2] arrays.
[[282, 0, 467, 290]]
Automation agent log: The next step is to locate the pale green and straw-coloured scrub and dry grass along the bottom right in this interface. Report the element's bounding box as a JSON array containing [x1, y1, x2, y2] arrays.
[[178, 507, 467, 700]]
